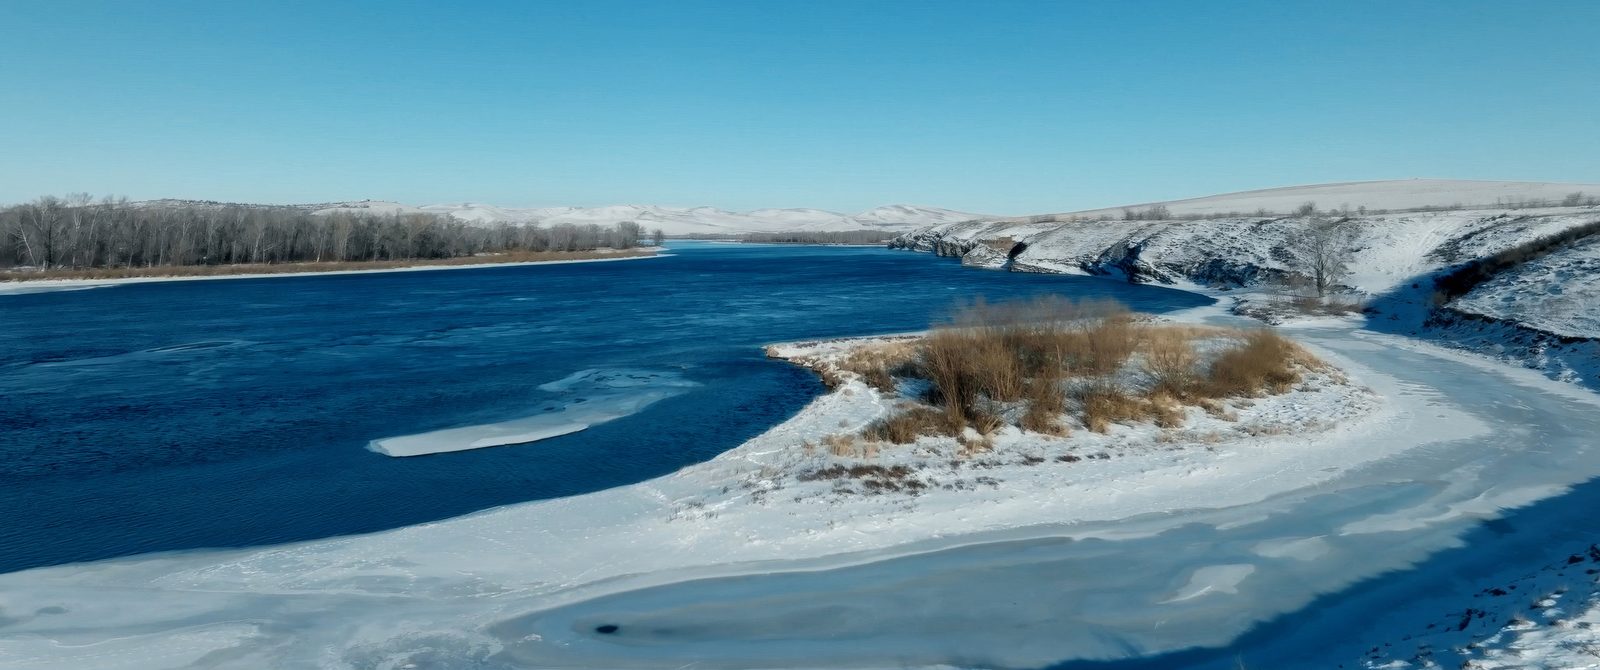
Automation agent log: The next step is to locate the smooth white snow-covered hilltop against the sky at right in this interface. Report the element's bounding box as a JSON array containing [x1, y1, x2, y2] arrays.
[[1059, 179, 1600, 219]]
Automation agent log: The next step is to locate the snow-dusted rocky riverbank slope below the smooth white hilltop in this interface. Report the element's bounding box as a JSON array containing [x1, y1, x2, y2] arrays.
[[891, 208, 1600, 296]]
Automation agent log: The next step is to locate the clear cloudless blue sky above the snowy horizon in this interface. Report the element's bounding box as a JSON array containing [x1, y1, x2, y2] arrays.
[[0, 0, 1600, 214]]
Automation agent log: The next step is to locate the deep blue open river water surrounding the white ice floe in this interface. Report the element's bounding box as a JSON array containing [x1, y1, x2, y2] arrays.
[[0, 243, 1208, 572]]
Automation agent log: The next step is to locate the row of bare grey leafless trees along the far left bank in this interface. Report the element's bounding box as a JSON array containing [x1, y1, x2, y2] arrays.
[[0, 193, 642, 269]]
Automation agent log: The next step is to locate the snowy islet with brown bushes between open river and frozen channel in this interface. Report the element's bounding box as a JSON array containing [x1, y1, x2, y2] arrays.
[[755, 301, 1379, 502]]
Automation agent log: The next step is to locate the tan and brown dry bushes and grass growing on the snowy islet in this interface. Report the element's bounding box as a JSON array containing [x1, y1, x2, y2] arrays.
[[827, 297, 1322, 454]]
